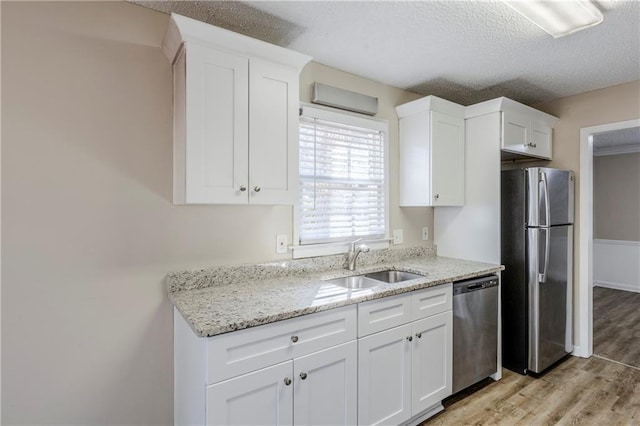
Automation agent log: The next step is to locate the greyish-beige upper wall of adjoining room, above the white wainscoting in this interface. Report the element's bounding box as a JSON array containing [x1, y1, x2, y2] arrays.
[[593, 153, 640, 241]]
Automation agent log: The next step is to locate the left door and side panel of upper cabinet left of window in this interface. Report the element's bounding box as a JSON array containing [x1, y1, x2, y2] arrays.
[[181, 44, 249, 204]]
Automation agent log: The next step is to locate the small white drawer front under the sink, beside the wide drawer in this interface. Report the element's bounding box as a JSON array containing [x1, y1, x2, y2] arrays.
[[358, 293, 411, 337]]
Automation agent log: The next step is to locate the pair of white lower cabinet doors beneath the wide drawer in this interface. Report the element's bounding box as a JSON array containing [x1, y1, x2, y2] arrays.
[[207, 341, 358, 426]]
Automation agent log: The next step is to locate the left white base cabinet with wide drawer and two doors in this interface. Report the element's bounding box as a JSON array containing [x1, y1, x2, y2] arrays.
[[174, 305, 358, 425]]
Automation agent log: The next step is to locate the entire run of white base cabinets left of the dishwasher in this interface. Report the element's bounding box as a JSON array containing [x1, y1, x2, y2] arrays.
[[174, 284, 453, 426]]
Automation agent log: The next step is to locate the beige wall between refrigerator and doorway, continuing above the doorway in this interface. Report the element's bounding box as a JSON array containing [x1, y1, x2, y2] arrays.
[[536, 80, 640, 346]]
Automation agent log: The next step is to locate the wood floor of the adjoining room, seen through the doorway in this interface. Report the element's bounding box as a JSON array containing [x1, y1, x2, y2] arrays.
[[593, 287, 640, 368]]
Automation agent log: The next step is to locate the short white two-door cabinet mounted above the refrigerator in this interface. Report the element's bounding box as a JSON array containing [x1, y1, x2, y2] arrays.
[[467, 97, 558, 160]]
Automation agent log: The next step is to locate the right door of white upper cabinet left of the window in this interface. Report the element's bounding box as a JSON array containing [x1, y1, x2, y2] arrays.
[[249, 59, 299, 204]]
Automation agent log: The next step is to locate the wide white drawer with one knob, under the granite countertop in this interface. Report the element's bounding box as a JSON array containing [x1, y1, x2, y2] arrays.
[[207, 305, 357, 384]]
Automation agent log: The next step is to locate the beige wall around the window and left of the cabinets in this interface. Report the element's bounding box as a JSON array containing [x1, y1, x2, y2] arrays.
[[1, 2, 433, 425]]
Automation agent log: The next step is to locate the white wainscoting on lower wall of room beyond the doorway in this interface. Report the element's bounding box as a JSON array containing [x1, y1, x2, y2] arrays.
[[593, 240, 640, 293]]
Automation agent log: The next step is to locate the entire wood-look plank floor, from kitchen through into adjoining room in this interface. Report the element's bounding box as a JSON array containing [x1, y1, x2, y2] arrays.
[[422, 287, 640, 426]]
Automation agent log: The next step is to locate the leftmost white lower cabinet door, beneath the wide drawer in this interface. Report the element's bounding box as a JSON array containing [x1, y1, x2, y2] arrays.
[[206, 361, 293, 426]]
